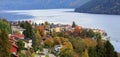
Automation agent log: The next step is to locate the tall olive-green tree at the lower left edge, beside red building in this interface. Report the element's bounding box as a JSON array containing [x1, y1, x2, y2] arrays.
[[0, 30, 11, 57]]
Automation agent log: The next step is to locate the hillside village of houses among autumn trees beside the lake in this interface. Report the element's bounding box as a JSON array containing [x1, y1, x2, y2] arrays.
[[0, 19, 116, 57]]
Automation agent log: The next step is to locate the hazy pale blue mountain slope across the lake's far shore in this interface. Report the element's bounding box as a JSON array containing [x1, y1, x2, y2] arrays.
[[0, 0, 89, 10]]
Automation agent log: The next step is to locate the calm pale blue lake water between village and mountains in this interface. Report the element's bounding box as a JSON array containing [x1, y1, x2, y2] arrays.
[[0, 9, 120, 52]]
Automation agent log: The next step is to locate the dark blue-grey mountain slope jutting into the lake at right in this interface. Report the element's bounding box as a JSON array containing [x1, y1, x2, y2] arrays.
[[75, 0, 120, 14]]
